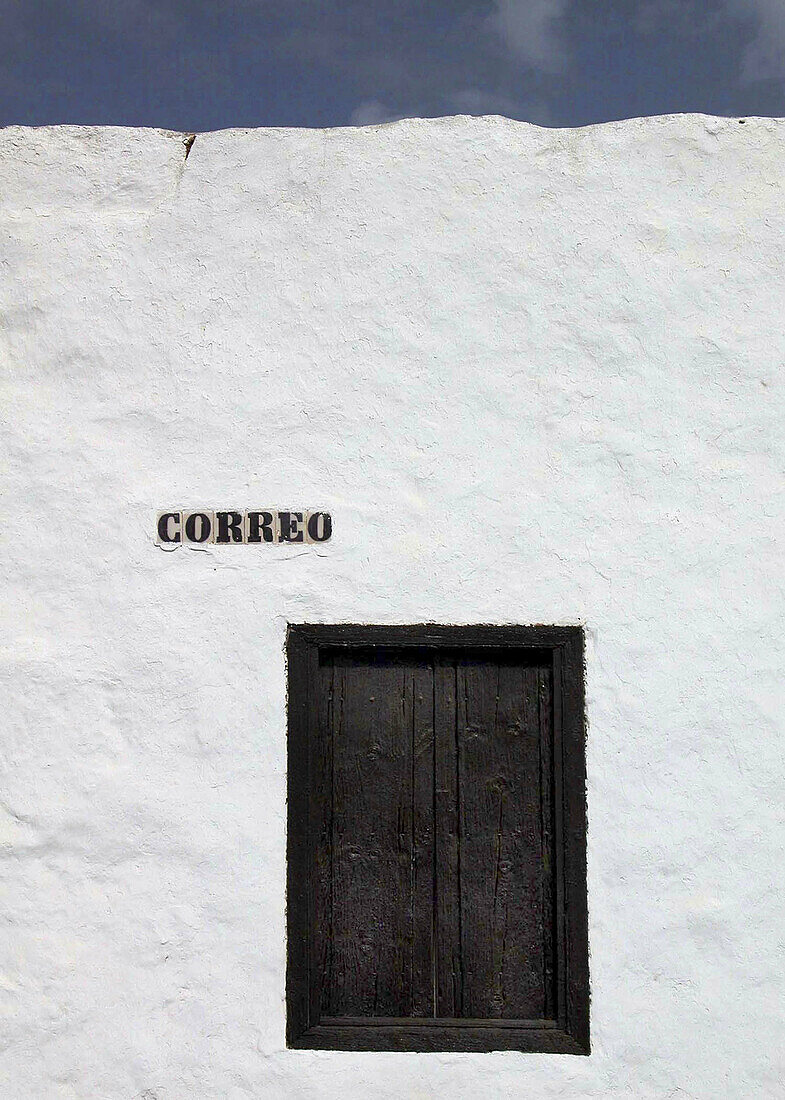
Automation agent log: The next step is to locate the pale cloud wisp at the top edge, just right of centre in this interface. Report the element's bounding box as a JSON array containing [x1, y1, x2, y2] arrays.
[[488, 0, 567, 73]]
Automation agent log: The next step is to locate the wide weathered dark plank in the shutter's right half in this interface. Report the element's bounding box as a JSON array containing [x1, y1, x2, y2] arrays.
[[456, 656, 545, 1019]]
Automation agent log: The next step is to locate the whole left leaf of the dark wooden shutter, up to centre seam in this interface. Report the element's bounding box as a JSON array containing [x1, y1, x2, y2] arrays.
[[317, 651, 433, 1016]]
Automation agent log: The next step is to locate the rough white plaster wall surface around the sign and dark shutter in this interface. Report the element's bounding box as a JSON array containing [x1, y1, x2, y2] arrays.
[[0, 116, 785, 1100]]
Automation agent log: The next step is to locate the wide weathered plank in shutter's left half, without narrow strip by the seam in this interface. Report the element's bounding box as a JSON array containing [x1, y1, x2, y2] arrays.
[[322, 653, 422, 1016]]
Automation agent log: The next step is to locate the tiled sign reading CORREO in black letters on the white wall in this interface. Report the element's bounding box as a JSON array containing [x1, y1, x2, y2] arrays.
[[156, 510, 332, 549]]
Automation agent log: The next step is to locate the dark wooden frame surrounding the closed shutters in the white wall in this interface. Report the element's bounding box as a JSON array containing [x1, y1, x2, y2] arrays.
[[286, 623, 589, 1054]]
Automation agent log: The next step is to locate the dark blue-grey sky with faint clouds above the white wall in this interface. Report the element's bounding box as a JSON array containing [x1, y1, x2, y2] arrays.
[[0, 0, 785, 131]]
